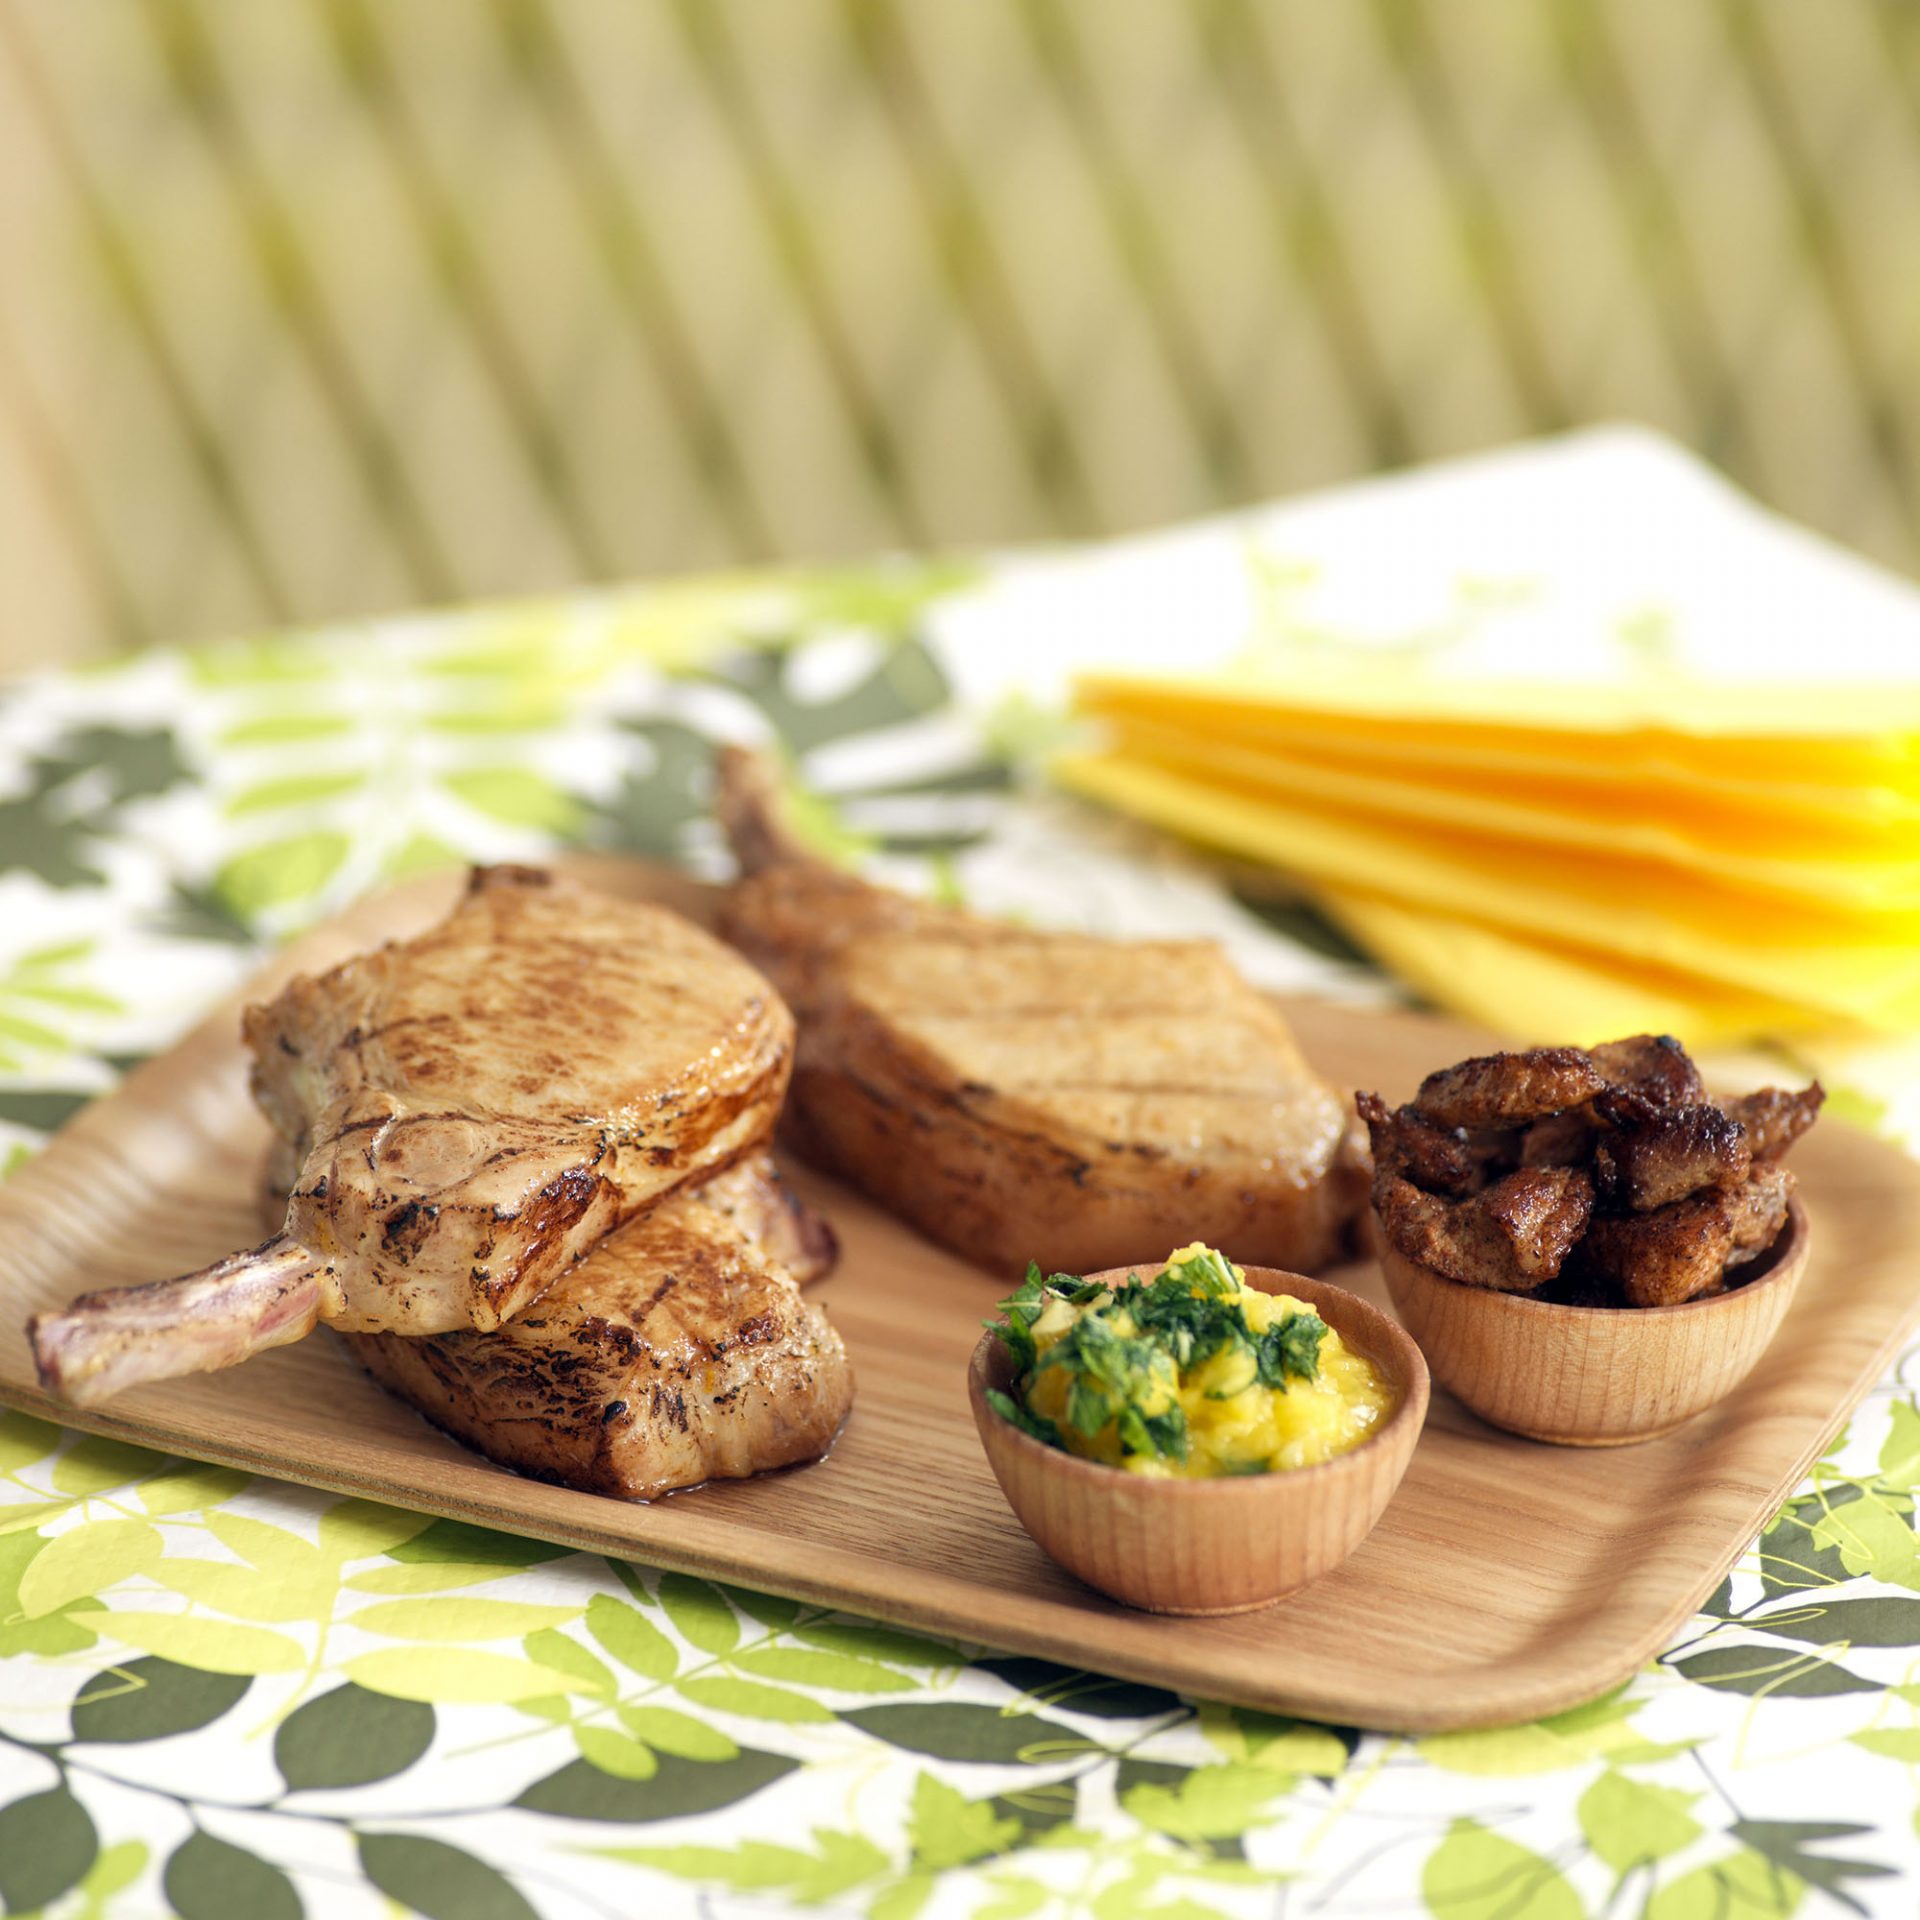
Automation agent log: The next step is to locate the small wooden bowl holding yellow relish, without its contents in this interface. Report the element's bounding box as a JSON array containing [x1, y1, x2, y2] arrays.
[[968, 1267, 1428, 1613]]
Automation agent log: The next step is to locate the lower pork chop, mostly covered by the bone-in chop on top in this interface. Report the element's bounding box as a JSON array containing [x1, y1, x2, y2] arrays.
[[346, 1156, 852, 1500]]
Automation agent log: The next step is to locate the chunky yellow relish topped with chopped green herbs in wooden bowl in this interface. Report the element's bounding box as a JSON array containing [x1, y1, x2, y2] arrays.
[[989, 1242, 1394, 1478]]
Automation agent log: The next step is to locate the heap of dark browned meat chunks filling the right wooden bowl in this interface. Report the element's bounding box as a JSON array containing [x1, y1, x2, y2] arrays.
[[1357, 1033, 1822, 1306]]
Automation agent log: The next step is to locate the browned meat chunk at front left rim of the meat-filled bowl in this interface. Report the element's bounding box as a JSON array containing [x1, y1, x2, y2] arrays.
[[1373, 1167, 1594, 1294]]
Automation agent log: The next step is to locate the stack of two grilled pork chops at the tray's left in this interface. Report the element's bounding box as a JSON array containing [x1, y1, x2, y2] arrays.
[[35, 868, 852, 1500]]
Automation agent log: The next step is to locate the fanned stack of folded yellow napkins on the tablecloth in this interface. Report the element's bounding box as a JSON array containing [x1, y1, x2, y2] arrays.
[[1056, 721, 1920, 1041]]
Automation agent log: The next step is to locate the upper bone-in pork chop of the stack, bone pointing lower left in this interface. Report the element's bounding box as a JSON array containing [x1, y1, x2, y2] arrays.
[[29, 868, 793, 1404]]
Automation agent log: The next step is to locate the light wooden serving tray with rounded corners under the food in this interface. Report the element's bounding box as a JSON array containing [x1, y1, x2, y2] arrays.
[[0, 860, 1920, 1732]]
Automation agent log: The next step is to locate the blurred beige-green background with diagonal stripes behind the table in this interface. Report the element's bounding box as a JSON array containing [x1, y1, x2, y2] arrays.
[[0, 0, 1920, 664]]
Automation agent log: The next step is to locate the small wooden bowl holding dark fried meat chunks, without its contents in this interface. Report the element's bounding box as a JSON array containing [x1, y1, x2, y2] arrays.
[[1373, 1196, 1807, 1446]]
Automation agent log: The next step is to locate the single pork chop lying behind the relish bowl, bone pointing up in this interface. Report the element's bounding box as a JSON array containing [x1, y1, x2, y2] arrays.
[[718, 749, 1367, 1273]]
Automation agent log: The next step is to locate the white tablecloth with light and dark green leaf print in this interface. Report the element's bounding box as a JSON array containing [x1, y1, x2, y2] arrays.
[[0, 438, 1920, 1920]]
